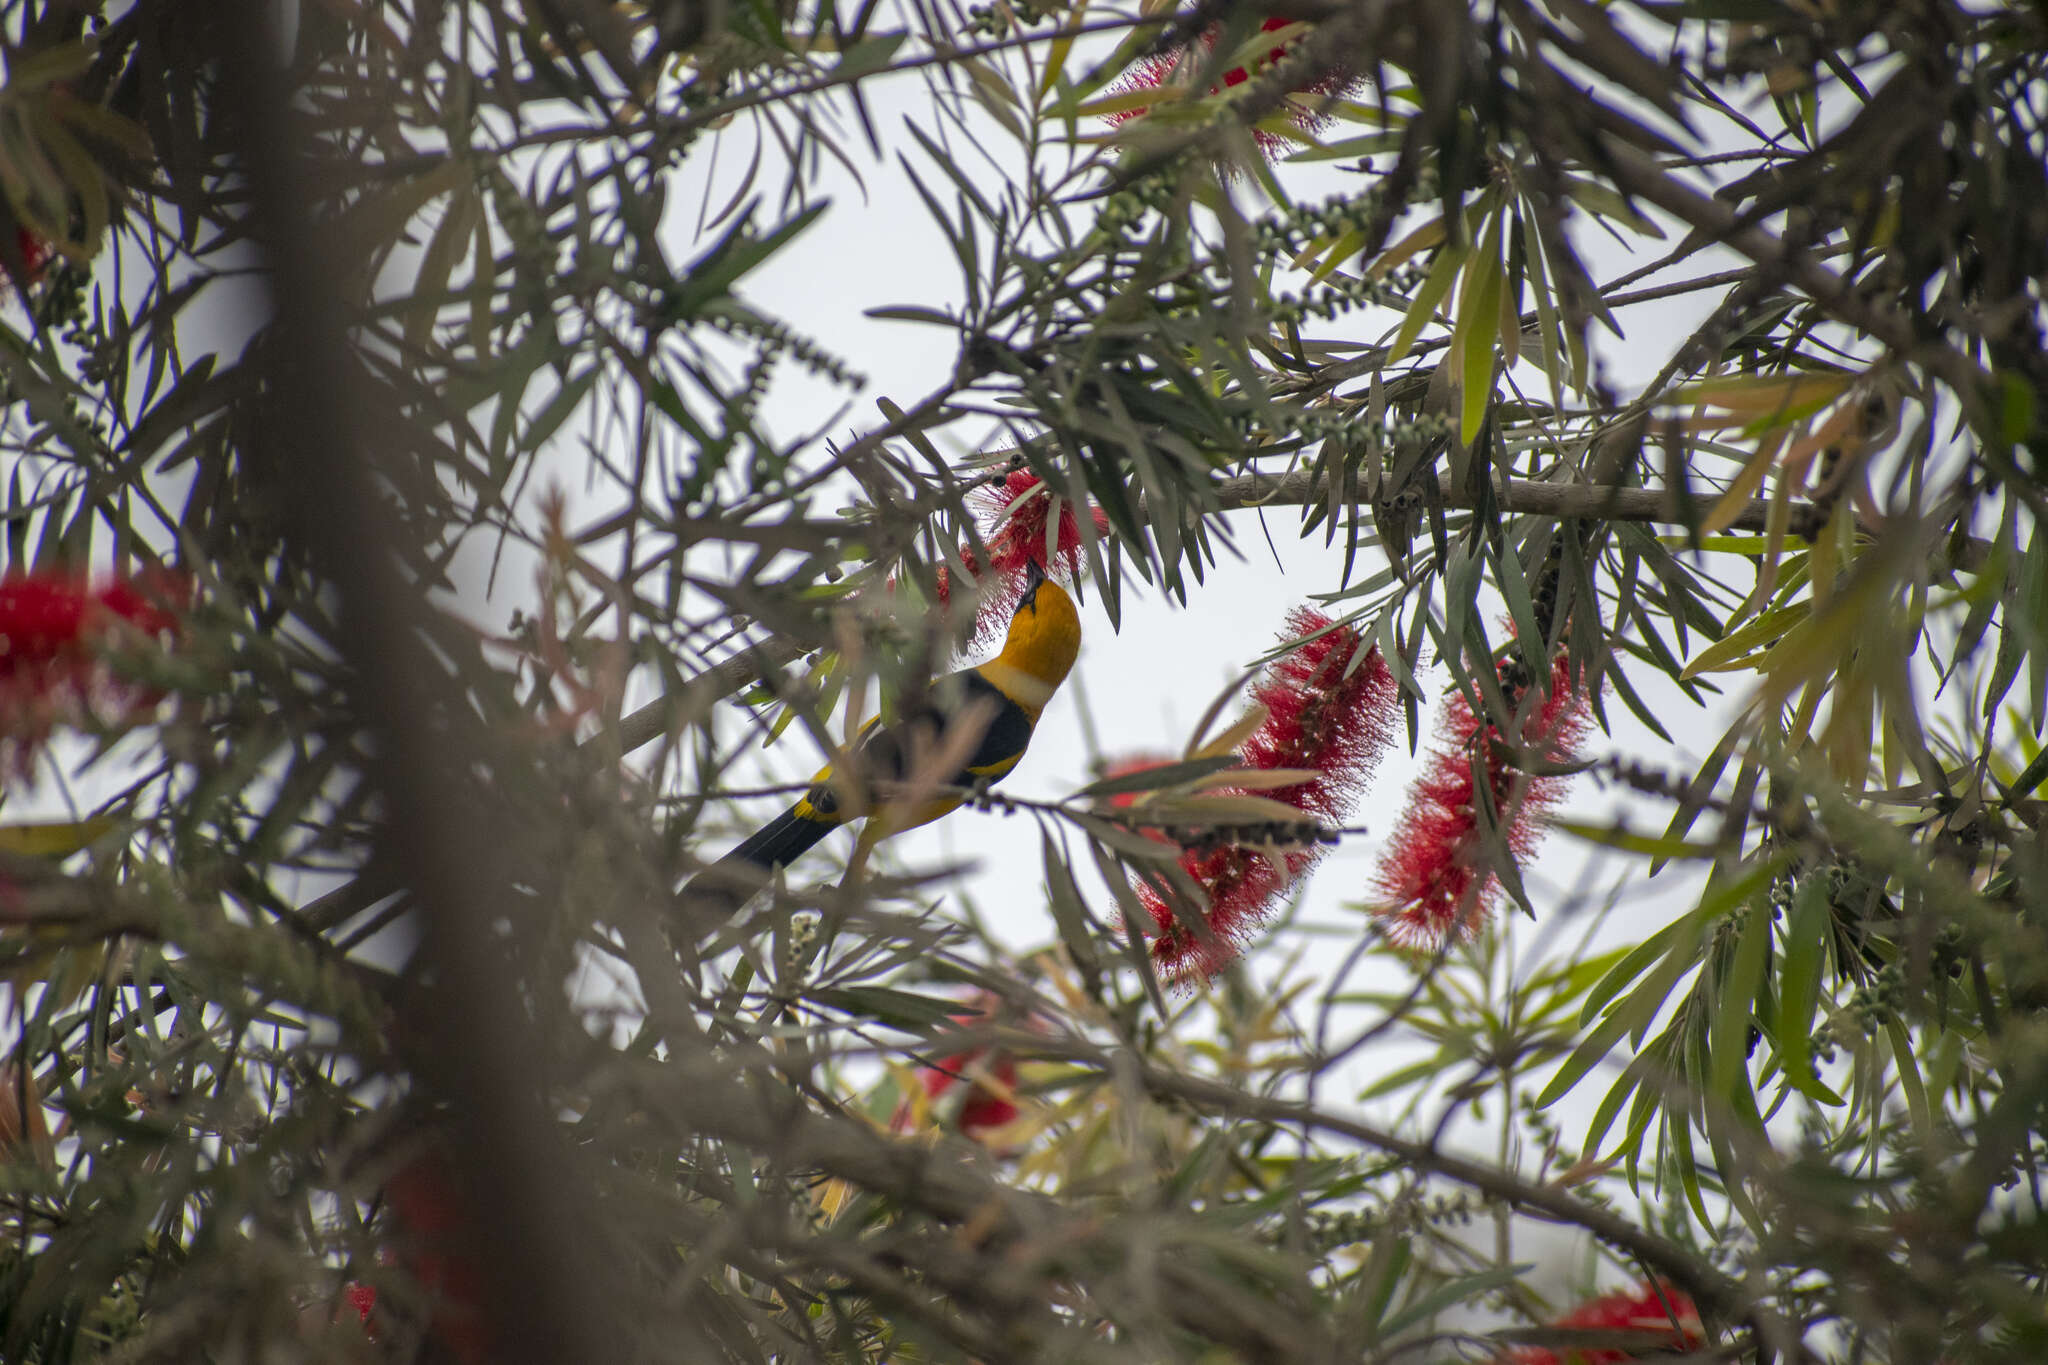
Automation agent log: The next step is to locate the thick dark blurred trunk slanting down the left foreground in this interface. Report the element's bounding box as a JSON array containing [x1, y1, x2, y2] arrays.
[[219, 4, 621, 1365]]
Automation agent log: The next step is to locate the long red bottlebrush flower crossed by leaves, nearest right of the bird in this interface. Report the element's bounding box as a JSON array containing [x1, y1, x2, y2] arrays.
[[1139, 608, 1395, 984]]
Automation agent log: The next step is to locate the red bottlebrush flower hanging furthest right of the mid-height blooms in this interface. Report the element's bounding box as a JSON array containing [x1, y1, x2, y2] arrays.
[[1374, 653, 1587, 948]]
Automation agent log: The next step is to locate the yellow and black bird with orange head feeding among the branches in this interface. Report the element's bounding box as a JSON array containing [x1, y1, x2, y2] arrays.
[[684, 565, 1081, 915]]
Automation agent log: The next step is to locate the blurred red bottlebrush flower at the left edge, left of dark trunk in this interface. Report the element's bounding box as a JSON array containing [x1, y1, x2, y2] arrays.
[[0, 569, 190, 776]]
